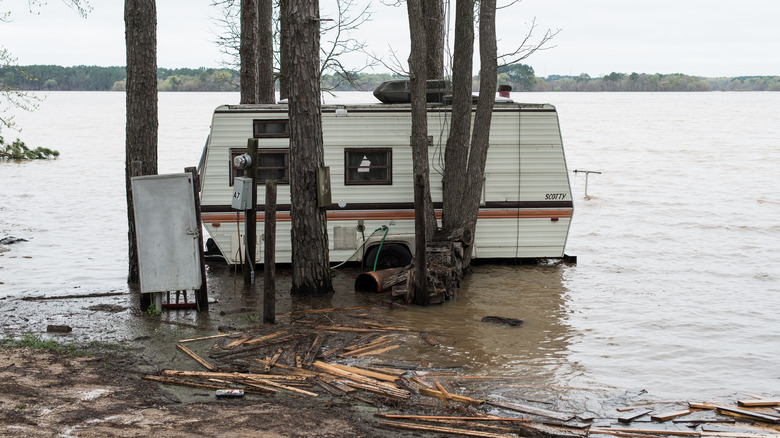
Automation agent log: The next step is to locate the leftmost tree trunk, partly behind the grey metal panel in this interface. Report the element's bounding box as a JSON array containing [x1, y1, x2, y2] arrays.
[[125, 0, 158, 284]]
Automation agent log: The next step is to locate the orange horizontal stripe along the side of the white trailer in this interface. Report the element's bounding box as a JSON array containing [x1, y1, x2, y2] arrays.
[[202, 209, 572, 224]]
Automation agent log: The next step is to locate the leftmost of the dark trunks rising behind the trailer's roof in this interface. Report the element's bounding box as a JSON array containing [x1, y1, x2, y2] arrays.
[[239, 0, 260, 103]]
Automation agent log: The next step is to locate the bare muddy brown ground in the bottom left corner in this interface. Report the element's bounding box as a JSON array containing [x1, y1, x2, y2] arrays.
[[0, 347, 426, 437]]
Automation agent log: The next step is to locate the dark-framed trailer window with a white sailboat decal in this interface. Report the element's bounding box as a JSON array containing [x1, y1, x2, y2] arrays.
[[344, 148, 393, 185]]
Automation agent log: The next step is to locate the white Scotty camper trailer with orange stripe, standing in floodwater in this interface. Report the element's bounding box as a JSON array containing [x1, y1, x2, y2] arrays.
[[199, 95, 573, 267]]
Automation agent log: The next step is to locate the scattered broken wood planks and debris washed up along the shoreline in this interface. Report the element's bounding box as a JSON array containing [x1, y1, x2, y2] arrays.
[[145, 306, 780, 438]]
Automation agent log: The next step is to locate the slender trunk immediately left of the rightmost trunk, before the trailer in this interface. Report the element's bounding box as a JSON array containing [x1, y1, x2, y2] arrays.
[[442, 0, 474, 230]]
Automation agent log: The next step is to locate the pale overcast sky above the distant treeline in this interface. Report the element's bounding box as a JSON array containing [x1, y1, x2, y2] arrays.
[[0, 0, 780, 77]]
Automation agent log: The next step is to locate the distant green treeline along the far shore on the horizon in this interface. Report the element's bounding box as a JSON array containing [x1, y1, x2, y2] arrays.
[[0, 64, 780, 92]]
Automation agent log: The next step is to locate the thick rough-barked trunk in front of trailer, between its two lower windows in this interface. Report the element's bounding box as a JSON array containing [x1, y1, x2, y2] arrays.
[[282, 0, 333, 295]]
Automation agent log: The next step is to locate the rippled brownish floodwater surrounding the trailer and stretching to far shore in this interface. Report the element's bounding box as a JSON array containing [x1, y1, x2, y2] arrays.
[[0, 92, 780, 400]]
